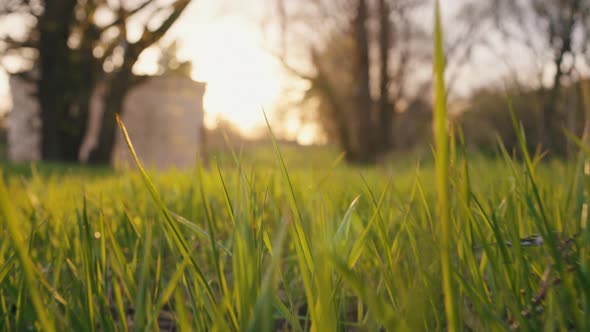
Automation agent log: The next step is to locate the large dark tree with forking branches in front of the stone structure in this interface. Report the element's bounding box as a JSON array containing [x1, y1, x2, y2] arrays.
[[0, 0, 190, 163]]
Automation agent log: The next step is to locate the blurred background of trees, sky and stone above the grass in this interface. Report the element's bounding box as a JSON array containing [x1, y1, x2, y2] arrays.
[[0, 0, 590, 168]]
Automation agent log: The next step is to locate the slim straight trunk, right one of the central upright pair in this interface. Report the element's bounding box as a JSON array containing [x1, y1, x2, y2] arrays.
[[378, 0, 393, 152]]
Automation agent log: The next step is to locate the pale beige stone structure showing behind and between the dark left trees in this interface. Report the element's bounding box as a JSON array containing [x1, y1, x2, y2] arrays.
[[8, 74, 206, 169]]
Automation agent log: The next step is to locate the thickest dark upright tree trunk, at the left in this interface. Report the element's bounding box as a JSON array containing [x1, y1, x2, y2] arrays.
[[37, 0, 96, 162]]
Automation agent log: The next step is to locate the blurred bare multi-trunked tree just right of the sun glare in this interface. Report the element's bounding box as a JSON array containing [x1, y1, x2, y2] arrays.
[[273, 0, 429, 162]]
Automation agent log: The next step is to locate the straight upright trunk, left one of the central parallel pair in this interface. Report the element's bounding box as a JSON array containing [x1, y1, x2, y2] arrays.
[[349, 0, 374, 163]]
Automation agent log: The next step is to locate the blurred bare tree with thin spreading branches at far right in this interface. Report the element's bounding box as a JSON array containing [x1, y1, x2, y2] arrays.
[[465, 0, 590, 156]]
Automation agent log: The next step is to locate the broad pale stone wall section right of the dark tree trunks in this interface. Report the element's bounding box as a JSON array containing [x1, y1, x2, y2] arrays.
[[115, 76, 205, 169]]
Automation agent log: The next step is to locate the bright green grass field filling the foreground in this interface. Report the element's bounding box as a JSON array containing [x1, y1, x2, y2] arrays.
[[0, 141, 590, 331]]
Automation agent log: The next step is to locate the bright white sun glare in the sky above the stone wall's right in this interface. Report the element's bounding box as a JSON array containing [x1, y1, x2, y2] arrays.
[[180, 16, 282, 136]]
